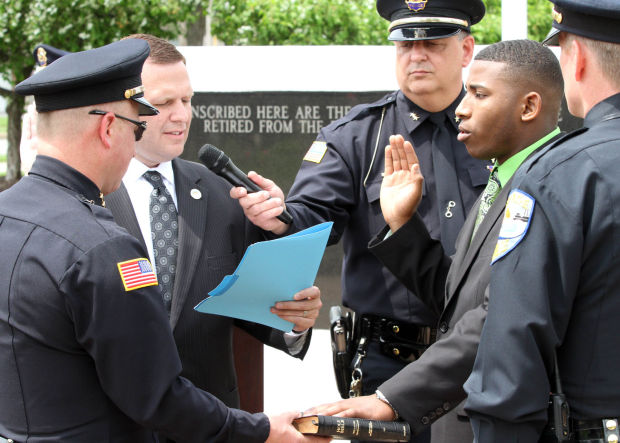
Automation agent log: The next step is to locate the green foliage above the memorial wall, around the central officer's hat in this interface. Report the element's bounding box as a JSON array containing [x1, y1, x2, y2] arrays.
[[212, 0, 551, 45]]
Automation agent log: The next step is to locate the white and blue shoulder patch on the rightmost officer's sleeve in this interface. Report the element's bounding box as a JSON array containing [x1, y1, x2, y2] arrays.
[[491, 189, 536, 264]]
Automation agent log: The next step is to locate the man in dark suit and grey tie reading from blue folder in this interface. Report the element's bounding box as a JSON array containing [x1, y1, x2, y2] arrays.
[[106, 35, 321, 407]]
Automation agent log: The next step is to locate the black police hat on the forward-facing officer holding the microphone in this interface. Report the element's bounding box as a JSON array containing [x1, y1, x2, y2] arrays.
[[377, 0, 485, 41]]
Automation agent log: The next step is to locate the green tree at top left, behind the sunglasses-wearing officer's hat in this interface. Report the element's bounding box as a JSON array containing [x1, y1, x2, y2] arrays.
[[0, 0, 208, 182]]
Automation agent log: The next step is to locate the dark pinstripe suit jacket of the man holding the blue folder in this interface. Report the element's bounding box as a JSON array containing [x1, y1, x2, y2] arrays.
[[106, 158, 310, 407]]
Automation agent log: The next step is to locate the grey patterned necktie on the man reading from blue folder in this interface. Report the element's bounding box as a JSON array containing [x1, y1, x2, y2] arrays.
[[144, 171, 179, 315]]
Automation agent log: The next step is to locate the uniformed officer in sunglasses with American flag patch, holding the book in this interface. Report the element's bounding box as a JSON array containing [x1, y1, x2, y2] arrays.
[[0, 39, 320, 442]]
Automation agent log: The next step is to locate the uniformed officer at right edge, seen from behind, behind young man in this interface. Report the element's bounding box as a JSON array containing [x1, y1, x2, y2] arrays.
[[465, 0, 620, 442]]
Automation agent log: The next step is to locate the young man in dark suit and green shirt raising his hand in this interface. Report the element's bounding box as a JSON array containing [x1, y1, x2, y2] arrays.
[[318, 40, 563, 442]]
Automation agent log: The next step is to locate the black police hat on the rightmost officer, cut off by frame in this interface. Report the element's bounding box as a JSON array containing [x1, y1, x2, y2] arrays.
[[543, 0, 620, 45]]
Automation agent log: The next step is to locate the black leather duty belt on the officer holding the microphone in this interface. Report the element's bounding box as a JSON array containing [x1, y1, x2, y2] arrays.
[[359, 314, 437, 362]]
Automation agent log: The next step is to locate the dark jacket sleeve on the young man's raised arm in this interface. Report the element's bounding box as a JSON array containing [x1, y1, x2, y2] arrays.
[[368, 214, 452, 314]]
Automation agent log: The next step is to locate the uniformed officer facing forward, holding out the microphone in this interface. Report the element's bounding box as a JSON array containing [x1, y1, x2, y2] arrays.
[[231, 0, 490, 441]]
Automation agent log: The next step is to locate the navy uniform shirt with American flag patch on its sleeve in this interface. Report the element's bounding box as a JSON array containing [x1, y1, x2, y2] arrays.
[[0, 156, 269, 442]]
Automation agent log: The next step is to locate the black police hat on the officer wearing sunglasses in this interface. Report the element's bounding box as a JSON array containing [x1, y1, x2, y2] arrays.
[[15, 39, 159, 115]]
